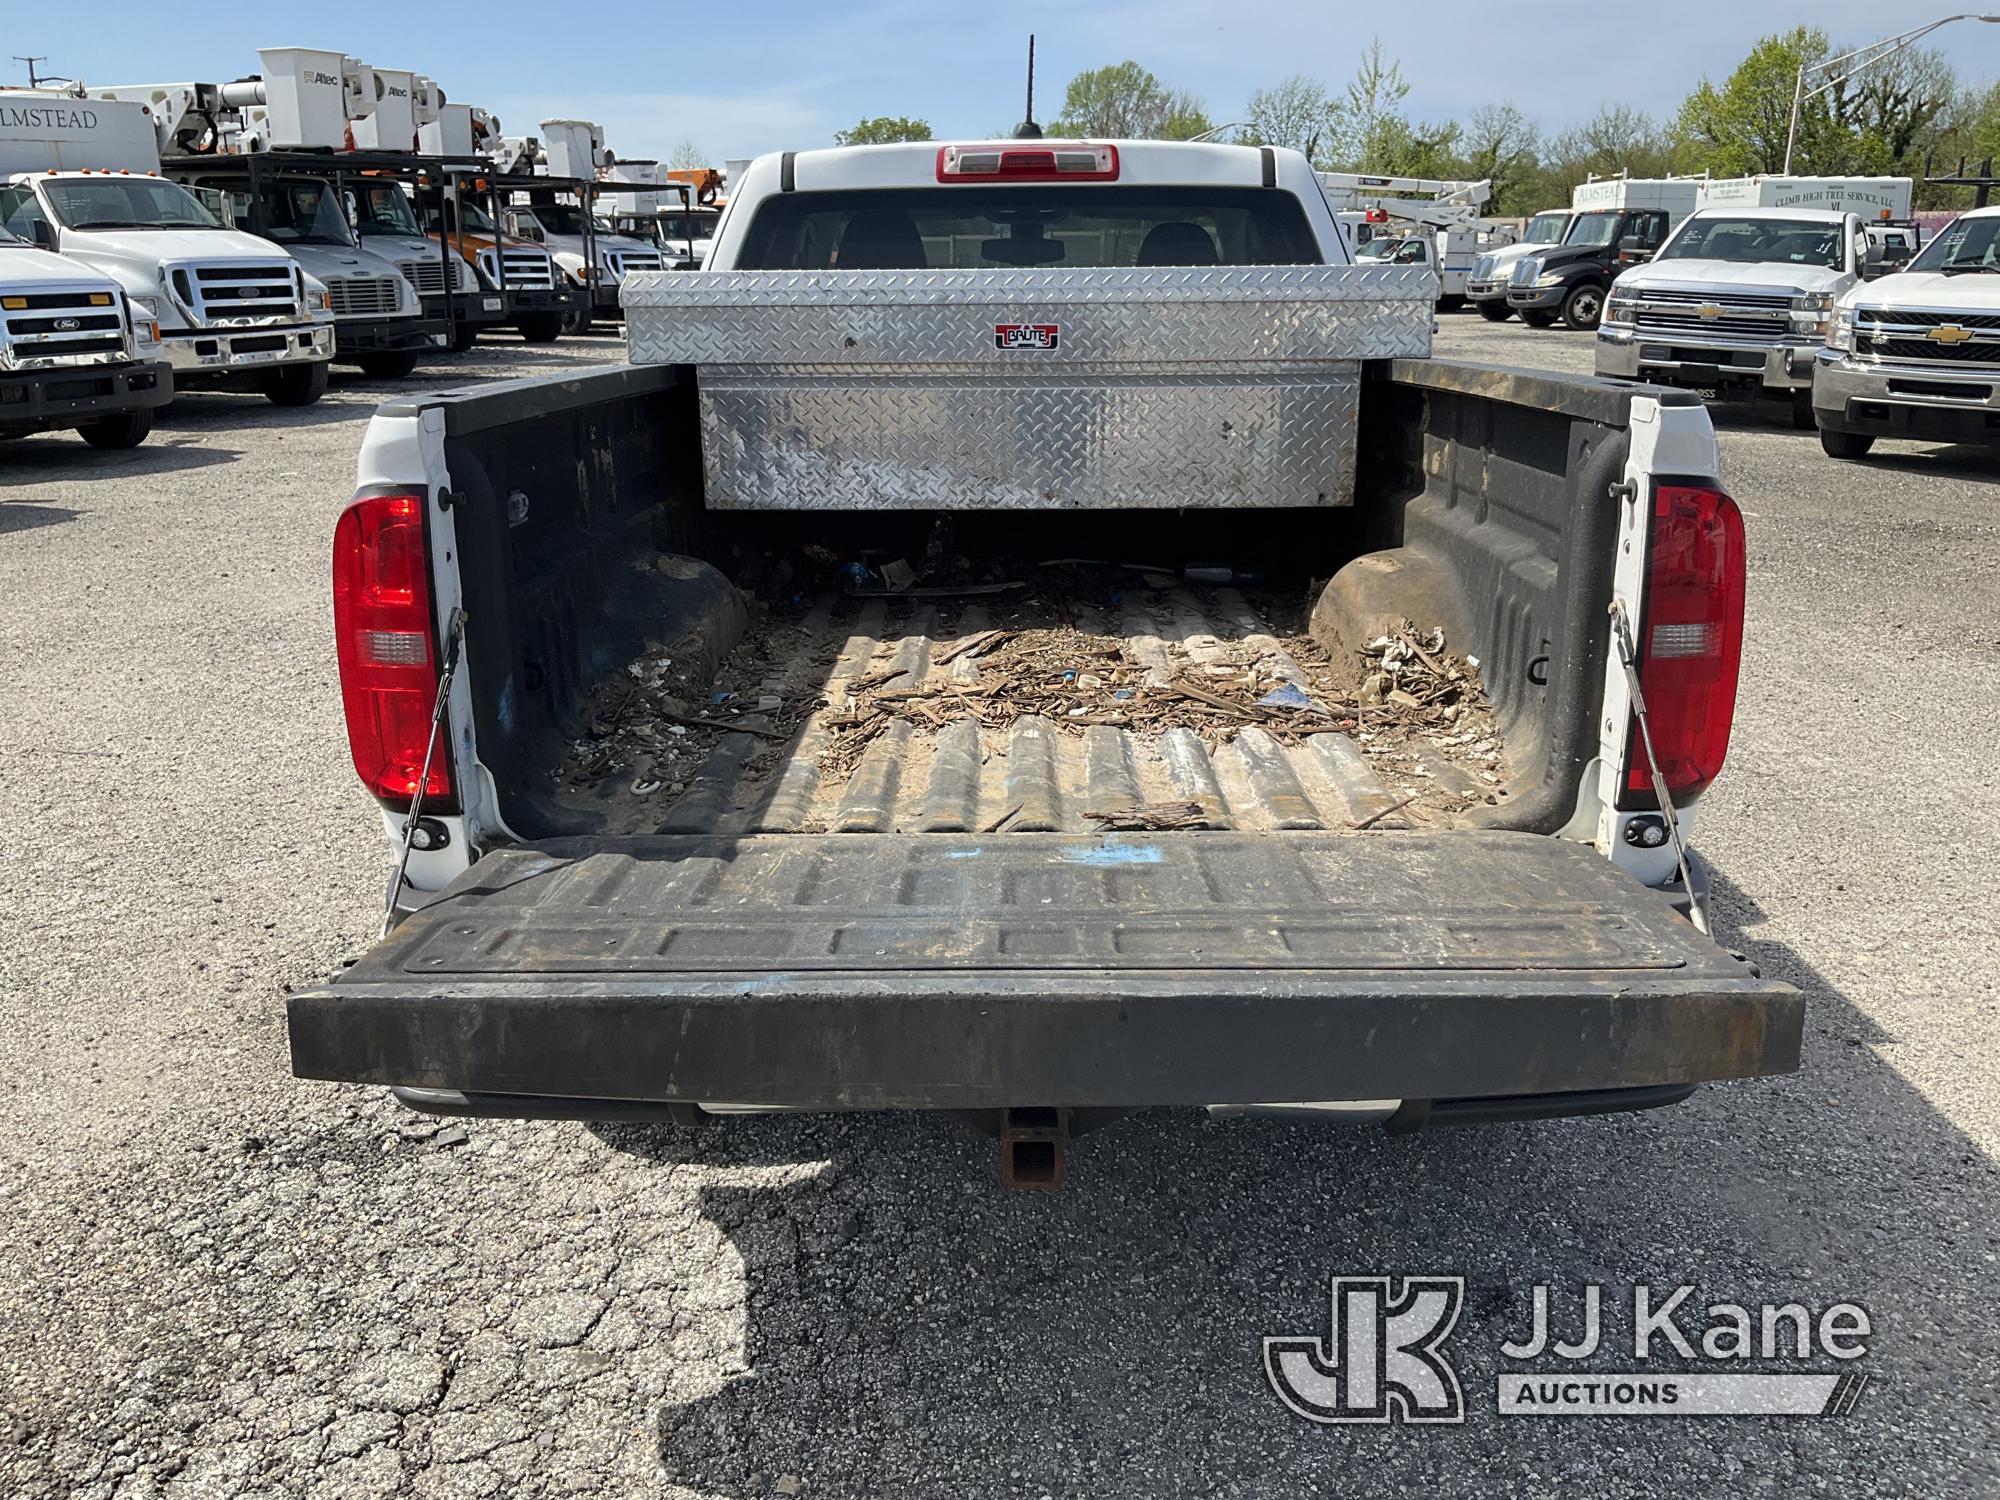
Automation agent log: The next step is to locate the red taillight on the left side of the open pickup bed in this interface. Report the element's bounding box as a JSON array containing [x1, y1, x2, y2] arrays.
[[334, 494, 452, 812]]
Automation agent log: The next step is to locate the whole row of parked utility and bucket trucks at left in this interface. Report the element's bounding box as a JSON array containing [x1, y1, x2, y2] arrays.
[[0, 48, 722, 446]]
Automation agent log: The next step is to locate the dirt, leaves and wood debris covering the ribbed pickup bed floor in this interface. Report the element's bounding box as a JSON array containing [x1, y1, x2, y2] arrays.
[[558, 568, 1508, 834]]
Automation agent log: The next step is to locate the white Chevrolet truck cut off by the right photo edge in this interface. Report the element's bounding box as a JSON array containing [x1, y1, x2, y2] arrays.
[[1812, 206, 2000, 458]]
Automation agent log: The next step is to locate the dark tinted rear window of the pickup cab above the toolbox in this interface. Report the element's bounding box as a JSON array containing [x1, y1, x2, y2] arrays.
[[736, 184, 1322, 270]]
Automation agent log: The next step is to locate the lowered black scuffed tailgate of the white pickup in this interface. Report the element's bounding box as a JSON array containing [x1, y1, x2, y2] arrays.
[[290, 832, 1804, 1108]]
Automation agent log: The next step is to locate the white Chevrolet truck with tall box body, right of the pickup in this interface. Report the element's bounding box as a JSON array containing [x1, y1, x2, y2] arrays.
[[1596, 176, 1910, 430]]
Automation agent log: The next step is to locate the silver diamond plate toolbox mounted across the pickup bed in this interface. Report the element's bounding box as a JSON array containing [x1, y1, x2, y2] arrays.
[[620, 266, 1436, 510]]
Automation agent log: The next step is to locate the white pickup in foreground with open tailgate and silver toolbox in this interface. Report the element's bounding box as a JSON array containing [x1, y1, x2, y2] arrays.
[[288, 140, 1802, 1184]]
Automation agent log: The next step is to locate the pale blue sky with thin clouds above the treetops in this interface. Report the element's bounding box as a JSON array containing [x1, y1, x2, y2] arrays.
[[11, 0, 2000, 162]]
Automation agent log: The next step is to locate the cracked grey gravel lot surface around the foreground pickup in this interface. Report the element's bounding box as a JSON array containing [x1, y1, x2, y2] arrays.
[[0, 316, 2000, 1500]]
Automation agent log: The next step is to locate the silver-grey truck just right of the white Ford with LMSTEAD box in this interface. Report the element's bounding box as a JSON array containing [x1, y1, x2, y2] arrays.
[[184, 170, 448, 380]]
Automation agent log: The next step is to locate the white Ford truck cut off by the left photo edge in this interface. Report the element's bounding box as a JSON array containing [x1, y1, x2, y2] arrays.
[[0, 219, 174, 448]]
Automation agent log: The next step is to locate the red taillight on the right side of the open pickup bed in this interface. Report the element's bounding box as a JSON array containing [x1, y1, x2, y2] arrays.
[[1620, 484, 1744, 806]]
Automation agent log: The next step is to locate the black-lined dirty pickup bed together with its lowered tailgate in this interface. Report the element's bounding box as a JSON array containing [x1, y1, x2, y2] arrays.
[[290, 362, 1802, 1118]]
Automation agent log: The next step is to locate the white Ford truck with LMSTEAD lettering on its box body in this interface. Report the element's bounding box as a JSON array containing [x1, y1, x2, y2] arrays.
[[0, 90, 334, 406]]
